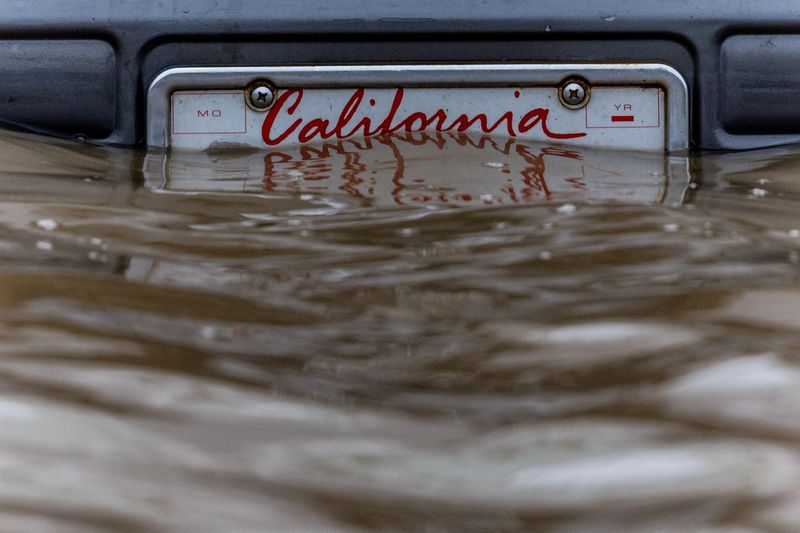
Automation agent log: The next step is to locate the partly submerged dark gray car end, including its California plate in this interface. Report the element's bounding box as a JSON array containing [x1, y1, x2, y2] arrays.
[[0, 0, 800, 152]]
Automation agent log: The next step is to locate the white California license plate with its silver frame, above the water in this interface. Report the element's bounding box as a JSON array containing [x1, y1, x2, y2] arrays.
[[148, 65, 688, 151]]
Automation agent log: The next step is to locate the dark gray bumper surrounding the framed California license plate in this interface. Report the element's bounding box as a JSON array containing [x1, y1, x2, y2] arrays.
[[0, 0, 800, 149]]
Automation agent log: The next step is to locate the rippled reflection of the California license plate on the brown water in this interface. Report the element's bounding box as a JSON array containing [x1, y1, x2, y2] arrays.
[[145, 132, 688, 206]]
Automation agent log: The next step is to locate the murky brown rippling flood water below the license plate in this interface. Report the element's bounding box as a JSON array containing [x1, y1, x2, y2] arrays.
[[0, 130, 800, 532]]
